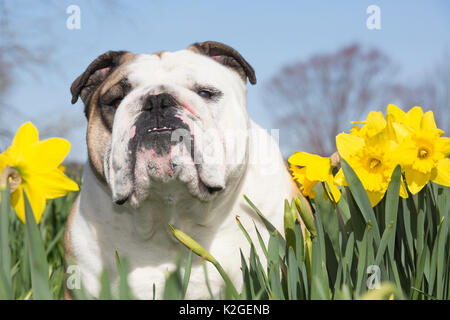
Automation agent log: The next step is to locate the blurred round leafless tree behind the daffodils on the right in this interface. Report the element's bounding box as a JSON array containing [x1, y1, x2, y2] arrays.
[[263, 44, 396, 155]]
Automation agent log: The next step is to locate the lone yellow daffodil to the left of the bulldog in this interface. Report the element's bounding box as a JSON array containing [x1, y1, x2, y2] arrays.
[[0, 122, 78, 223]]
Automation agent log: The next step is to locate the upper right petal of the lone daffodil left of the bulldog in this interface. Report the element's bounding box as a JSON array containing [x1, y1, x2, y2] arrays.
[[27, 138, 70, 172]]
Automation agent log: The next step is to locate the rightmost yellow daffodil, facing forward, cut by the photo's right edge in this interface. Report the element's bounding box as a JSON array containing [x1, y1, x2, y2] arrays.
[[387, 105, 450, 194]]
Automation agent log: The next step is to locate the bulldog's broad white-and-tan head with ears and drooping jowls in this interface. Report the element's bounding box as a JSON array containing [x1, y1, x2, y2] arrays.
[[71, 41, 256, 207]]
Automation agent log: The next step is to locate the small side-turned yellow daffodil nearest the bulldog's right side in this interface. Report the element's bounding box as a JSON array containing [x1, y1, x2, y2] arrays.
[[288, 151, 341, 202]]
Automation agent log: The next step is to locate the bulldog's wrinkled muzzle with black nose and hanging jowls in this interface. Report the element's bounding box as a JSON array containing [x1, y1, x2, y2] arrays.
[[104, 92, 226, 207]]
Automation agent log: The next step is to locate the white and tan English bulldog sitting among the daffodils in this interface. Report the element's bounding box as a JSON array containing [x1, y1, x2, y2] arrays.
[[64, 41, 298, 299]]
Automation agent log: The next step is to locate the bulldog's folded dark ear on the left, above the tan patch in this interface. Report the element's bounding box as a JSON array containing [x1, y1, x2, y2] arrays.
[[70, 51, 128, 105]]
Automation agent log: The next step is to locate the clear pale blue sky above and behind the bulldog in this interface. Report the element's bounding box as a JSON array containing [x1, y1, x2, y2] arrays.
[[3, 0, 450, 161]]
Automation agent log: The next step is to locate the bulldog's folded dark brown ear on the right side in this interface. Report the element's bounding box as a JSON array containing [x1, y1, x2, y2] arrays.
[[188, 41, 256, 84]]
